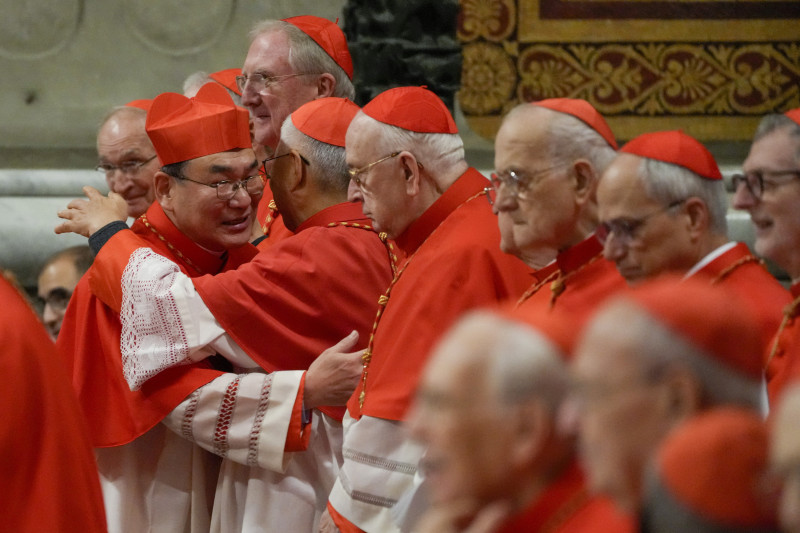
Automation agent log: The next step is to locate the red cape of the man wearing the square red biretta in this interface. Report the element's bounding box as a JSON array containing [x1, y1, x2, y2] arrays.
[[57, 203, 258, 447]]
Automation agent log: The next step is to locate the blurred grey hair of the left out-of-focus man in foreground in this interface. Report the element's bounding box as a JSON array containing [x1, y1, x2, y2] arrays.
[[459, 311, 569, 416]]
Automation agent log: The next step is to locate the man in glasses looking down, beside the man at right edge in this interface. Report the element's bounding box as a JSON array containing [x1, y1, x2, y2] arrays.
[[597, 131, 790, 404]]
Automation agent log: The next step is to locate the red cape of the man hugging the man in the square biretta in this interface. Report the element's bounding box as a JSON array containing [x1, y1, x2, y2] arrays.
[[194, 202, 395, 420]]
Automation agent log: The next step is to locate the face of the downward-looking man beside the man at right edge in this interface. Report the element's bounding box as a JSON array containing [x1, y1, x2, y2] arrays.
[[597, 154, 695, 283]]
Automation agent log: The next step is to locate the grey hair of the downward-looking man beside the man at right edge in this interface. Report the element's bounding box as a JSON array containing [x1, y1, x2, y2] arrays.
[[638, 158, 728, 235]]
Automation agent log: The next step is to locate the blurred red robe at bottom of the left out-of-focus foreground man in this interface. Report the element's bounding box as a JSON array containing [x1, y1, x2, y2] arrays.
[[495, 464, 636, 533]]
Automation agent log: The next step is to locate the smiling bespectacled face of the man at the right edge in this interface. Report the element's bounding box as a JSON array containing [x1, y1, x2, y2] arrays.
[[733, 128, 800, 278]]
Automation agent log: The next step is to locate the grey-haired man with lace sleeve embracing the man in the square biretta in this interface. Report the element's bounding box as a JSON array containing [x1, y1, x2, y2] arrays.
[[56, 98, 395, 531]]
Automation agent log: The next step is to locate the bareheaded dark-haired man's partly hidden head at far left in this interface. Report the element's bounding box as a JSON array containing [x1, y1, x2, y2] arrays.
[[37, 245, 94, 336]]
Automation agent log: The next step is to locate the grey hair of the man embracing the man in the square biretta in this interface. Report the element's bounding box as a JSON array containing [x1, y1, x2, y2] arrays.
[[281, 115, 350, 193]]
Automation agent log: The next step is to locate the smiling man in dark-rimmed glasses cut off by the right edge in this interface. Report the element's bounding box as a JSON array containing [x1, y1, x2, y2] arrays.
[[733, 108, 800, 402]]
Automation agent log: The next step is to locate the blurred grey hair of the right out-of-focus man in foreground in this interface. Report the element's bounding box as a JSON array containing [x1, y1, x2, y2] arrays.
[[611, 301, 761, 410]]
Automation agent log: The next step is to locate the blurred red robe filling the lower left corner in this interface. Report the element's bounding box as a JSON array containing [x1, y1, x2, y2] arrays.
[[0, 276, 106, 533]]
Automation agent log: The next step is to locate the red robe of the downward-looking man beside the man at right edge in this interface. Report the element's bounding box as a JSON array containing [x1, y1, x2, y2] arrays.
[[693, 242, 792, 403]]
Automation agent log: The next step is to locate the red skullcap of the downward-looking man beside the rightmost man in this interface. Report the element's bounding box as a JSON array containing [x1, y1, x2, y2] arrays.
[[620, 130, 722, 180]]
